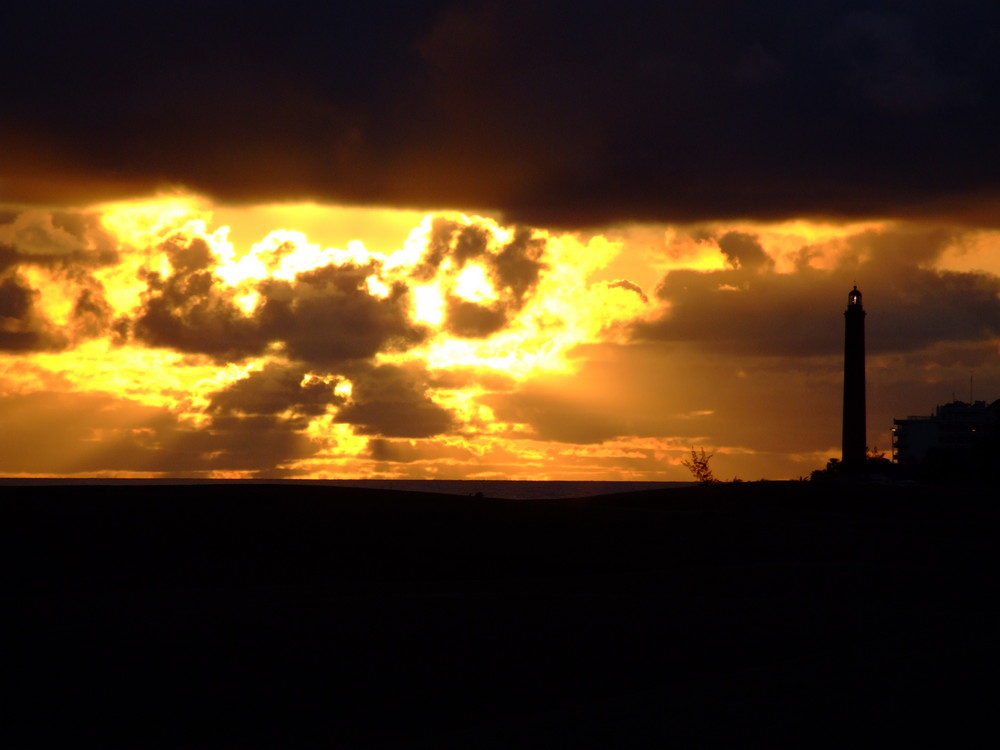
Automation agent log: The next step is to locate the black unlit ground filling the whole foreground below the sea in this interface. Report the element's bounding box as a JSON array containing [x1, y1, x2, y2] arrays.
[[0, 483, 1000, 748]]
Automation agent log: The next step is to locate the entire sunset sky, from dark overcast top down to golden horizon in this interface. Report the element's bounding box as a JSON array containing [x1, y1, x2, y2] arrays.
[[0, 0, 1000, 480]]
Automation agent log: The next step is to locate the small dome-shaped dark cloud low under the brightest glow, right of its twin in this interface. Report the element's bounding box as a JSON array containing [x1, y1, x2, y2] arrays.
[[336, 365, 454, 438]]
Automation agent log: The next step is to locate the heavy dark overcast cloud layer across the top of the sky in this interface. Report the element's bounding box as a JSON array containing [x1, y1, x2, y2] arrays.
[[0, 0, 1000, 225]]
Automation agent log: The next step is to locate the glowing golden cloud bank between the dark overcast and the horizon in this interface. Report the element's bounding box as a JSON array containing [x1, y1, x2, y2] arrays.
[[0, 200, 1000, 479]]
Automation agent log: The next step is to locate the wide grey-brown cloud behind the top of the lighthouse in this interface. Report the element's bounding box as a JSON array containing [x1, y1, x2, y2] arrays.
[[635, 228, 1000, 357]]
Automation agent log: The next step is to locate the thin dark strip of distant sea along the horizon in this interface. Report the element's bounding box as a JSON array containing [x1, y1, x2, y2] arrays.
[[0, 478, 693, 500]]
